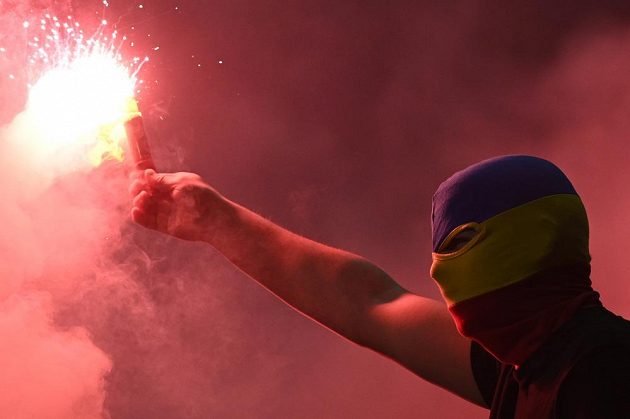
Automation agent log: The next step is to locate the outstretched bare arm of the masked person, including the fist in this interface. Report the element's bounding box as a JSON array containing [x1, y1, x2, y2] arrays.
[[131, 171, 483, 405]]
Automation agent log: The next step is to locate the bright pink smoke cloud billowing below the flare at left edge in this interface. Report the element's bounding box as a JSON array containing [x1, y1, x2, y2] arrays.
[[0, 112, 111, 419]]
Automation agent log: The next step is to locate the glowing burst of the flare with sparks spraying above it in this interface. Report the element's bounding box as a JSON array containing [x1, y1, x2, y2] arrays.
[[5, 12, 148, 166]]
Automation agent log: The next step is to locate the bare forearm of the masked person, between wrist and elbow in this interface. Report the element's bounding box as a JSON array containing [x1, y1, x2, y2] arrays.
[[204, 195, 402, 344]]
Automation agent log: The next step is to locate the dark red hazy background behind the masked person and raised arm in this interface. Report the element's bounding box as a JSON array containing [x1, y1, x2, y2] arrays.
[[0, 0, 630, 419]]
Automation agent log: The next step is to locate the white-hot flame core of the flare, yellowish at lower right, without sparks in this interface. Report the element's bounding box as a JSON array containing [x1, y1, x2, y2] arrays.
[[28, 51, 139, 167]]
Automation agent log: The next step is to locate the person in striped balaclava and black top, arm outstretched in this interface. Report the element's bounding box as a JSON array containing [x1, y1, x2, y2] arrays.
[[131, 156, 630, 419]]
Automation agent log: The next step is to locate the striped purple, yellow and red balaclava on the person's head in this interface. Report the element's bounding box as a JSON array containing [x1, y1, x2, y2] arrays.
[[431, 156, 599, 365]]
